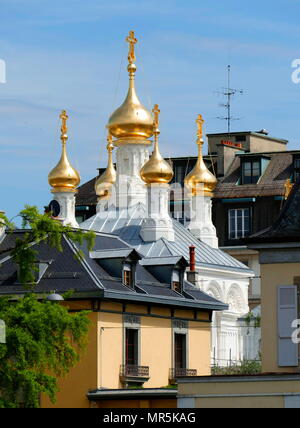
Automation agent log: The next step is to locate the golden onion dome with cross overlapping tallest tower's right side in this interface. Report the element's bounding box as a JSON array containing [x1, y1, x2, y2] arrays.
[[140, 104, 173, 184]]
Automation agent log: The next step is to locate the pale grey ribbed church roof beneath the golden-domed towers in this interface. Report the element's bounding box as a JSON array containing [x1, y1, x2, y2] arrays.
[[80, 204, 249, 272]]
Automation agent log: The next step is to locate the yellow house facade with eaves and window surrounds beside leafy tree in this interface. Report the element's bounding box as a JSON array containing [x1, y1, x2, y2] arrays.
[[41, 301, 211, 408]]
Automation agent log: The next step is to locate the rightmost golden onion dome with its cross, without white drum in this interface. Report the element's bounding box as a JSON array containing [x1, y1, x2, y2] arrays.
[[184, 114, 217, 196]]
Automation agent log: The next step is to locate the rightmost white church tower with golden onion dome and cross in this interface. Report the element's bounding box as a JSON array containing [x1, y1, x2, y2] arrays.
[[184, 114, 218, 248]]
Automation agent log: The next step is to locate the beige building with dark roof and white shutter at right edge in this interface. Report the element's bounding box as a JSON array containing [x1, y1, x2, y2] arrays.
[[178, 182, 300, 408]]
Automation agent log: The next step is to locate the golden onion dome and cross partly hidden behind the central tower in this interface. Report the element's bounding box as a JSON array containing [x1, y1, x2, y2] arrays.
[[95, 133, 117, 200]]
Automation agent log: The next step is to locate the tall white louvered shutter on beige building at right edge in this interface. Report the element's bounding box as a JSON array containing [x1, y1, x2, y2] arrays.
[[277, 285, 298, 367]]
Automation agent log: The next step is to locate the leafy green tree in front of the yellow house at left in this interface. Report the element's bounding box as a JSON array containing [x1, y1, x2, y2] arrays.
[[0, 206, 94, 408]]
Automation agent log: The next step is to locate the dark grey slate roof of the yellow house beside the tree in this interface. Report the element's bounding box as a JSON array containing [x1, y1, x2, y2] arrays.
[[0, 231, 227, 310]]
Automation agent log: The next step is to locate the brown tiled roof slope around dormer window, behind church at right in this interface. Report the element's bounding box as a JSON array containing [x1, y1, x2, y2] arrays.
[[214, 152, 293, 199]]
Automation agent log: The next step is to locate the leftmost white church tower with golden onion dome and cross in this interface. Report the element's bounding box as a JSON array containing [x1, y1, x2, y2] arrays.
[[48, 110, 80, 227]]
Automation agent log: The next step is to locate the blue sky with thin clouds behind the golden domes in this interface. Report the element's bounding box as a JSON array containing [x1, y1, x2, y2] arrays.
[[0, 0, 300, 221]]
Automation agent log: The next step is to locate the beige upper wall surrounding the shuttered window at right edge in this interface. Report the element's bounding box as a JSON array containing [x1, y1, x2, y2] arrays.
[[261, 263, 300, 372]]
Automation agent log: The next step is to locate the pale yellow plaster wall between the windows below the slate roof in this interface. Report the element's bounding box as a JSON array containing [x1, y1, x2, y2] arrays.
[[41, 302, 211, 408]]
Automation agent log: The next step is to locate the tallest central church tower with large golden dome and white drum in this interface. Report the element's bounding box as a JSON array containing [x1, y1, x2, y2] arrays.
[[107, 31, 153, 208]]
